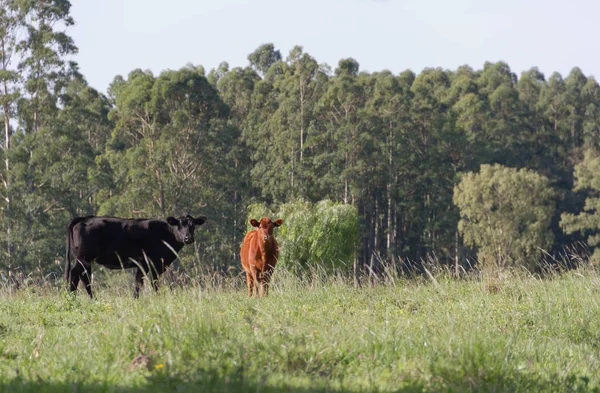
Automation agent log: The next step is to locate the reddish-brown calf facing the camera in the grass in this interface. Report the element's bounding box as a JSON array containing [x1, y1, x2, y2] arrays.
[[240, 217, 283, 297]]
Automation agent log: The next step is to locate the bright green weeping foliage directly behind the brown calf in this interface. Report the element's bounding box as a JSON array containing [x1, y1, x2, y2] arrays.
[[247, 200, 358, 272]]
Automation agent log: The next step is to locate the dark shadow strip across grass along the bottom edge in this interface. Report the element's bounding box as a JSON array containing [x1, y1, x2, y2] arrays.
[[0, 370, 600, 393]]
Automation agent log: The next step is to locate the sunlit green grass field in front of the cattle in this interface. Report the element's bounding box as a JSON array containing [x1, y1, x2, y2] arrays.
[[0, 271, 600, 393]]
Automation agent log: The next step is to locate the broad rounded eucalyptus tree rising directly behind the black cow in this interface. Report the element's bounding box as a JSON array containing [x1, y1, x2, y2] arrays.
[[101, 68, 231, 215]]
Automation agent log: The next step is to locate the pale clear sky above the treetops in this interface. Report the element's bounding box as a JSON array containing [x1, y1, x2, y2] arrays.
[[67, 0, 600, 92]]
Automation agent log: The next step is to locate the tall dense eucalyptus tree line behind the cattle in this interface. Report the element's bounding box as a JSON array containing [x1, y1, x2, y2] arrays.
[[0, 0, 600, 278]]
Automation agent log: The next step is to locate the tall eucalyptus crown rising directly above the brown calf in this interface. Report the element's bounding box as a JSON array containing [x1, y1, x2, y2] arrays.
[[243, 47, 327, 203]]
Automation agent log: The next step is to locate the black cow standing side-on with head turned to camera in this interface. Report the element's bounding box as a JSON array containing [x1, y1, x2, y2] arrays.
[[65, 214, 206, 298]]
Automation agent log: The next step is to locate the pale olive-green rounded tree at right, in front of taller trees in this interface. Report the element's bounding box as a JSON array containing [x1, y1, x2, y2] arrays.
[[454, 165, 554, 269]]
